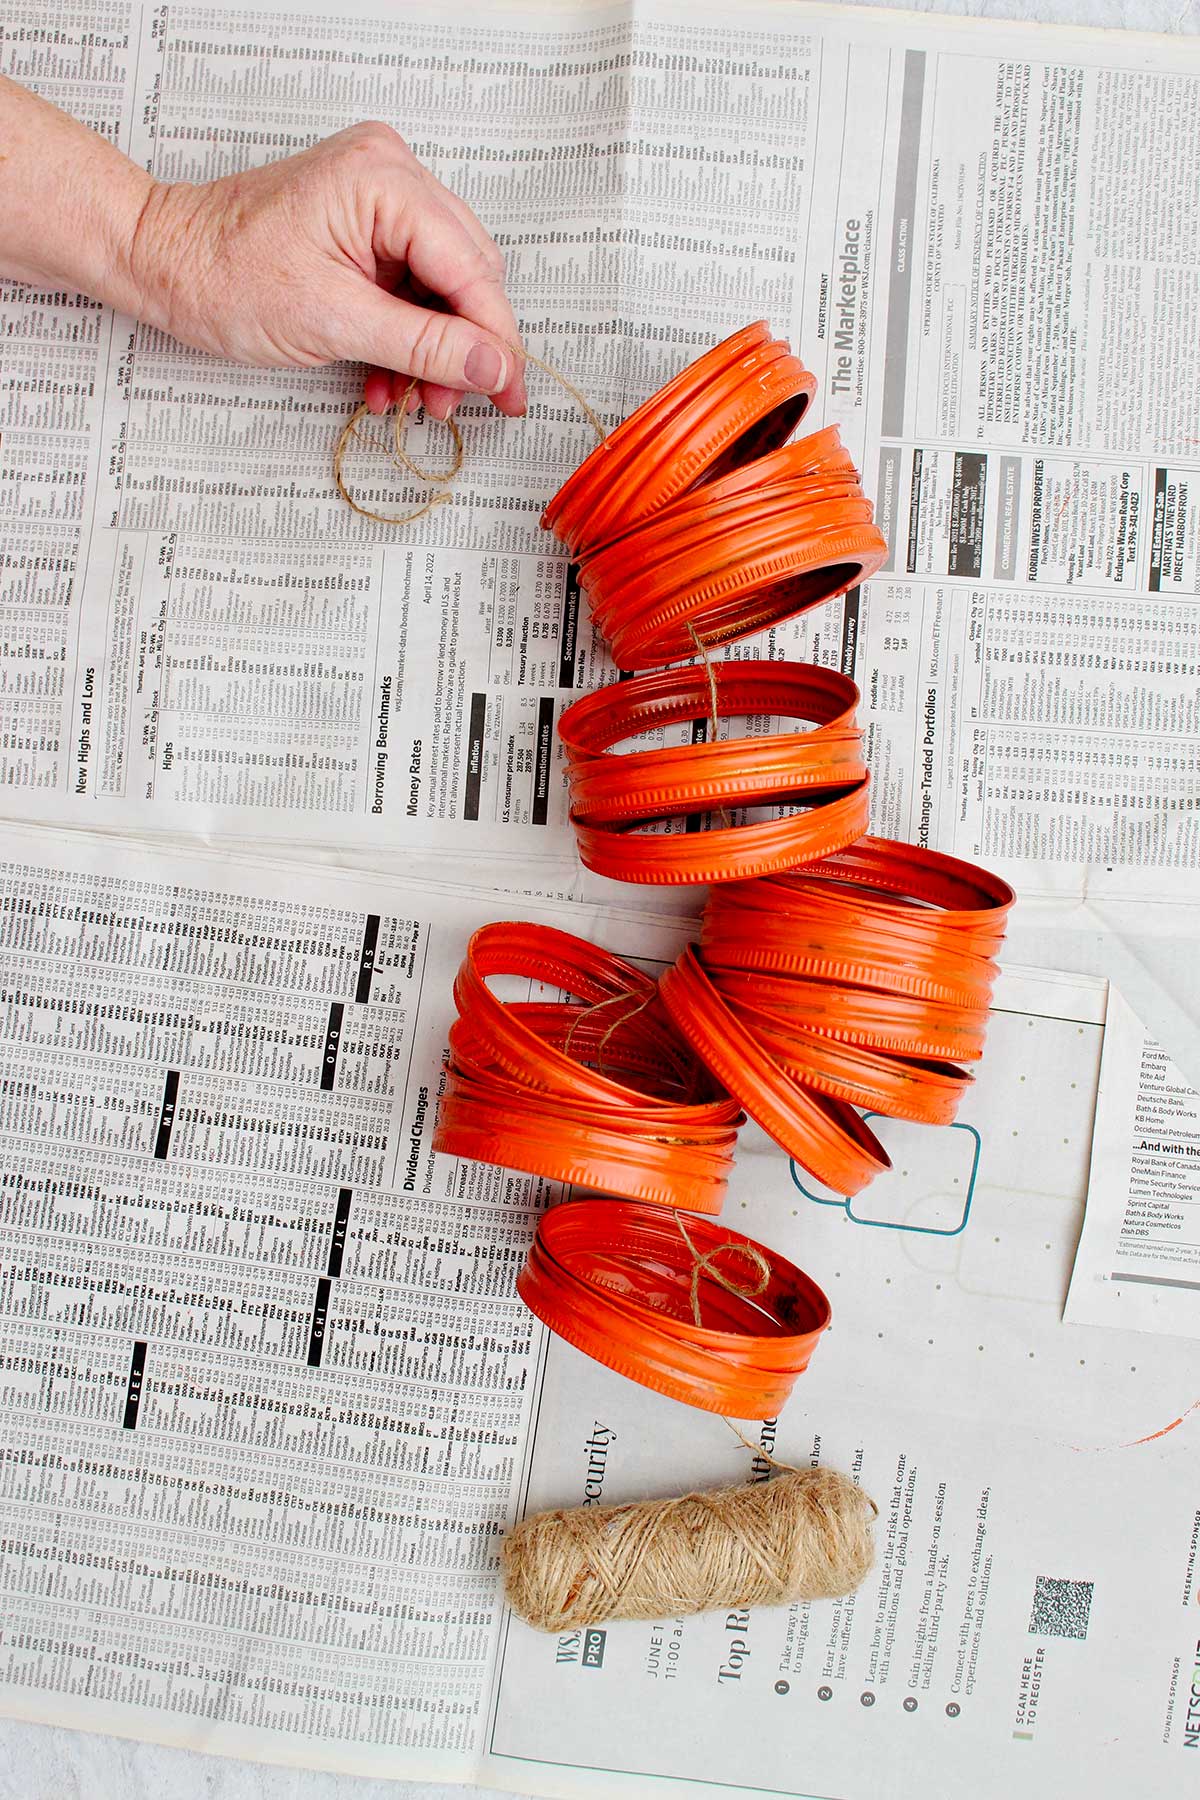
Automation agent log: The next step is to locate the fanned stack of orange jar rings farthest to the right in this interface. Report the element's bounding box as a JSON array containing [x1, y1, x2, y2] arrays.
[[658, 837, 1013, 1195]]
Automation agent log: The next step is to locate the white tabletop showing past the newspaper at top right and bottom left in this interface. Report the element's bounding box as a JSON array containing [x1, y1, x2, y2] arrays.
[[0, 0, 1200, 1800]]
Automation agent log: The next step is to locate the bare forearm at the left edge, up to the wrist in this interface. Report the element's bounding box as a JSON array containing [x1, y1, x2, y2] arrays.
[[0, 76, 157, 313]]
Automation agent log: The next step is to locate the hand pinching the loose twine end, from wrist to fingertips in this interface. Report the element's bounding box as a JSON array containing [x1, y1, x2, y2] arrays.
[[130, 124, 525, 419]]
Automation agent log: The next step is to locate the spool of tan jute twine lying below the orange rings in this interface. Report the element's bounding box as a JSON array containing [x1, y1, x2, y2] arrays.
[[500, 1469, 876, 1633]]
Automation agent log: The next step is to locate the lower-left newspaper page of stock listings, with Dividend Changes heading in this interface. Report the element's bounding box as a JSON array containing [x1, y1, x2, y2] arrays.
[[0, 830, 684, 1780]]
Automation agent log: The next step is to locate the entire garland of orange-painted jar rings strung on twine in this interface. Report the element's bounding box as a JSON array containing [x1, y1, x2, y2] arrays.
[[435, 324, 1013, 1418]]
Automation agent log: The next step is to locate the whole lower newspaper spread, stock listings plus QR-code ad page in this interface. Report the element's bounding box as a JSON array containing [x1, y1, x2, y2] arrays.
[[0, 828, 1200, 1800]]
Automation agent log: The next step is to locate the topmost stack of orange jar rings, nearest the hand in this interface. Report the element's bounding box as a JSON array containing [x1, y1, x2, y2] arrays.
[[542, 322, 887, 670]]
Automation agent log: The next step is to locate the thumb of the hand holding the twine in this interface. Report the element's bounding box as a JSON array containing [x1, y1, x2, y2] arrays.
[[333, 281, 516, 394]]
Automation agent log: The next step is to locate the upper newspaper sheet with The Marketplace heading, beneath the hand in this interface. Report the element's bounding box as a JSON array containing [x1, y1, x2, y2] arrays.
[[0, 0, 1200, 904]]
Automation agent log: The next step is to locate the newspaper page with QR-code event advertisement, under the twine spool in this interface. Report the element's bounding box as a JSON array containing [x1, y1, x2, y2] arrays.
[[488, 972, 1200, 1800]]
